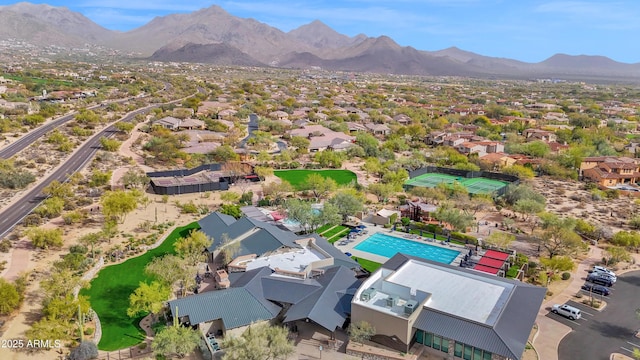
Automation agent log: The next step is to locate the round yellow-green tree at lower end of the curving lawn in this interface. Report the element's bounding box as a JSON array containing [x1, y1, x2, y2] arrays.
[[151, 326, 200, 358]]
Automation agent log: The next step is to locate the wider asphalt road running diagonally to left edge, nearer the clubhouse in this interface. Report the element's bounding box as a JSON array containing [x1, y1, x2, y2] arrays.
[[0, 104, 162, 239]]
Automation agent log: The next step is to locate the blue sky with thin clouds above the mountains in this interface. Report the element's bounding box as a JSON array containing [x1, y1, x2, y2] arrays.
[[0, 0, 640, 63]]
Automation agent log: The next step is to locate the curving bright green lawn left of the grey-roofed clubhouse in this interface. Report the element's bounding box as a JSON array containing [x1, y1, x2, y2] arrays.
[[81, 222, 198, 351]]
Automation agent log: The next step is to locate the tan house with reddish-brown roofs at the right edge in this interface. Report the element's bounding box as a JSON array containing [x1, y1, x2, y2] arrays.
[[580, 156, 640, 187]]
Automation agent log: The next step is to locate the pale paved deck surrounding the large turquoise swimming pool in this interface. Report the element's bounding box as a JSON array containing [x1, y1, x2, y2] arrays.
[[333, 222, 469, 266]]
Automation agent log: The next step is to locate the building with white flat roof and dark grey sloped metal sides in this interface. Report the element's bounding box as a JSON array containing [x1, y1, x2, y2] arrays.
[[351, 253, 546, 360]]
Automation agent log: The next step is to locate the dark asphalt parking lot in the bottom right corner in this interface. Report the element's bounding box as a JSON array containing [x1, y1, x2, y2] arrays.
[[548, 271, 640, 360]]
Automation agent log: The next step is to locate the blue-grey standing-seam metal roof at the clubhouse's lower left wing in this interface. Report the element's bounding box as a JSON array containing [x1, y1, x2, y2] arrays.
[[169, 288, 277, 329]]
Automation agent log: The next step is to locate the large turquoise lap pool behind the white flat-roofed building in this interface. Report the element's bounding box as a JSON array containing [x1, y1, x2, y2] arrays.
[[354, 233, 460, 264]]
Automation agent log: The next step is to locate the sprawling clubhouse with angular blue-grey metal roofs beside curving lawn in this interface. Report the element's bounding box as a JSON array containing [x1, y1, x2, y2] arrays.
[[169, 212, 360, 336]]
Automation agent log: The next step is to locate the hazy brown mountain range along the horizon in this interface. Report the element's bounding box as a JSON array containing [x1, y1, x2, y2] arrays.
[[0, 2, 640, 82]]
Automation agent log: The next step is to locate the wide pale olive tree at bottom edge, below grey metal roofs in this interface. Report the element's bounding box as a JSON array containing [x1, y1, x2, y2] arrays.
[[222, 324, 295, 360]]
